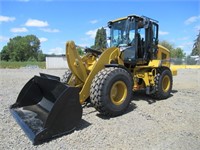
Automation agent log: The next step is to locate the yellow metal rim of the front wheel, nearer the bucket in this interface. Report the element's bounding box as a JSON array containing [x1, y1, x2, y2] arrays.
[[110, 81, 128, 105]]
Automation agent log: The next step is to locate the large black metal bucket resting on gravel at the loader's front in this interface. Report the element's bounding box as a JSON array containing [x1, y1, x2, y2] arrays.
[[10, 74, 82, 144]]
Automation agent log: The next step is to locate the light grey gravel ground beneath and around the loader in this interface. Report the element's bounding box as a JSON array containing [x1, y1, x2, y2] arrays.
[[0, 69, 200, 150]]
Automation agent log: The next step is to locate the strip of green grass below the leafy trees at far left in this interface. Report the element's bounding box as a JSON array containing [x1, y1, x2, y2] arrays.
[[0, 61, 45, 69]]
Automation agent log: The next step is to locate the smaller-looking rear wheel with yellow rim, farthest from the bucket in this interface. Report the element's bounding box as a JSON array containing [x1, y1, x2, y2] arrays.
[[151, 68, 173, 100]]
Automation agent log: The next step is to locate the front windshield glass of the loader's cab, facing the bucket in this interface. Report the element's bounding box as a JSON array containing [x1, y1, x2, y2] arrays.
[[110, 19, 135, 47]]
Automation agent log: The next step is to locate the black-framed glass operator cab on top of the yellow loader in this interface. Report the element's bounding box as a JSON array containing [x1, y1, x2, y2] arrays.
[[108, 15, 158, 66]]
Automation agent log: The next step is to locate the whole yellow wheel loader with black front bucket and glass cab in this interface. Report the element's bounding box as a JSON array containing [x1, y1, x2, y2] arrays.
[[10, 15, 176, 144]]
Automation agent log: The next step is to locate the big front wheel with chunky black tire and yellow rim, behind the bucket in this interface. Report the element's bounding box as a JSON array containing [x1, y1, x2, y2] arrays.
[[90, 67, 133, 117]]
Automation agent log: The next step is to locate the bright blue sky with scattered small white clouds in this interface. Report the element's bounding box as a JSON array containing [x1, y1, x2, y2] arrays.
[[0, 0, 200, 54]]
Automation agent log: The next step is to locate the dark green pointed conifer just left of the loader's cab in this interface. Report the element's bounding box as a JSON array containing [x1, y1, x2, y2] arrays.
[[92, 27, 107, 50]]
